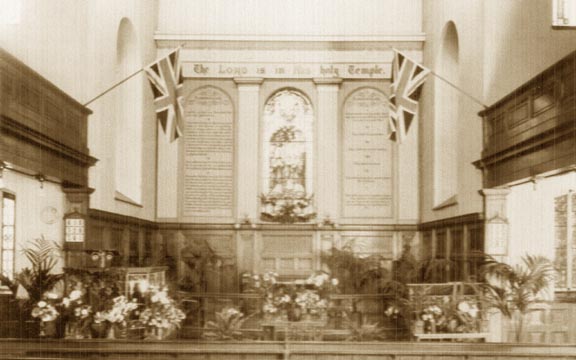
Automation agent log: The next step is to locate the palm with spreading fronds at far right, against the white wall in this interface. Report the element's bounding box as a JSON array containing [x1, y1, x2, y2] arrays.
[[481, 255, 556, 342]]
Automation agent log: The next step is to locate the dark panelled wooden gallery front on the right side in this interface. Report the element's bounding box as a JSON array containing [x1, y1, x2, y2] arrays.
[[476, 52, 576, 188]]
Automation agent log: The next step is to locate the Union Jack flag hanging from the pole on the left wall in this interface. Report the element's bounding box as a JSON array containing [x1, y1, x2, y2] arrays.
[[144, 48, 184, 142]]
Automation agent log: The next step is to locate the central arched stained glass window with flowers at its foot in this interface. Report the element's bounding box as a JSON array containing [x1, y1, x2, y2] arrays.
[[262, 89, 315, 223]]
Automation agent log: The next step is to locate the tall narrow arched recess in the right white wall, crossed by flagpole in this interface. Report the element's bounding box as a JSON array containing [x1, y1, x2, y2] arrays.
[[434, 21, 460, 207]]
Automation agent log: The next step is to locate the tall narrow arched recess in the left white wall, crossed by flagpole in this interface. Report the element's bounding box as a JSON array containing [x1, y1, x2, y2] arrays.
[[115, 18, 144, 203]]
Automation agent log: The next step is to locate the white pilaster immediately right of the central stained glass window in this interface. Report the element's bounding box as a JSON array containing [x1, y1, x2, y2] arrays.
[[314, 79, 342, 221]]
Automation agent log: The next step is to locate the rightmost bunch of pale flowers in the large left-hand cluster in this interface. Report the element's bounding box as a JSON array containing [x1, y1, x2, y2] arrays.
[[139, 288, 186, 338]]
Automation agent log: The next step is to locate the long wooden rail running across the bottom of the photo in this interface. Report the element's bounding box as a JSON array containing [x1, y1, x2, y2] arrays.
[[0, 340, 576, 360]]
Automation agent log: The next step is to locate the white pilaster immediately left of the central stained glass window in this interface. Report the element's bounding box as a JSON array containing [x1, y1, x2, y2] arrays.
[[234, 78, 262, 221]]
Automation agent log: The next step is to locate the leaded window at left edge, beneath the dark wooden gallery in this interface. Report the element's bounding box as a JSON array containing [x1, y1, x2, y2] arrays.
[[0, 192, 16, 279]]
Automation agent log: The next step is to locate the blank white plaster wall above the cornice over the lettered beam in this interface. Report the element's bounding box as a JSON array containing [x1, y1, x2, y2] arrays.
[[158, 0, 422, 39]]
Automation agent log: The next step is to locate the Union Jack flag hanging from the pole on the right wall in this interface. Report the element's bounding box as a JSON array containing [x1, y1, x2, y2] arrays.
[[388, 50, 430, 143]]
